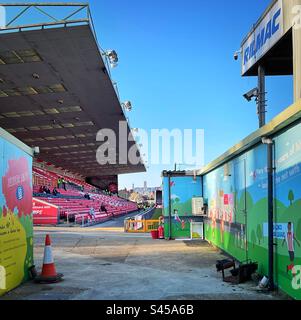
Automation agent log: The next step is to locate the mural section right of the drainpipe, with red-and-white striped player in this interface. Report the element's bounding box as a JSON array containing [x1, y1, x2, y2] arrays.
[[274, 125, 301, 299]]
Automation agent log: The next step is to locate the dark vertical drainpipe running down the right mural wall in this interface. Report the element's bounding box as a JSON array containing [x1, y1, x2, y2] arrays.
[[262, 138, 275, 291]]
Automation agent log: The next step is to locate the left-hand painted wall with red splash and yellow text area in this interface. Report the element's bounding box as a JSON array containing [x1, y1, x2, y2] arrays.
[[0, 137, 33, 295]]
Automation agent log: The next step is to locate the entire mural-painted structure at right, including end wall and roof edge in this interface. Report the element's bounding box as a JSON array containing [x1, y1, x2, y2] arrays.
[[163, 100, 301, 300]]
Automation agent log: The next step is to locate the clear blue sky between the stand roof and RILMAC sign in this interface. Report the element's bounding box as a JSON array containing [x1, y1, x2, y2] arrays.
[[7, 0, 293, 188]]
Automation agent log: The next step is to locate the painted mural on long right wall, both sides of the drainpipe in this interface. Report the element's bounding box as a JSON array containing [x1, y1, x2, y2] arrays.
[[204, 125, 301, 299]]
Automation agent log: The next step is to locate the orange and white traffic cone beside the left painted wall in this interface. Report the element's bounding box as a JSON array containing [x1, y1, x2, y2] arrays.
[[35, 234, 63, 283]]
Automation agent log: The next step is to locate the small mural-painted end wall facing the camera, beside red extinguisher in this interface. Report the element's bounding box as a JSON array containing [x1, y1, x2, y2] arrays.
[[163, 176, 202, 239]]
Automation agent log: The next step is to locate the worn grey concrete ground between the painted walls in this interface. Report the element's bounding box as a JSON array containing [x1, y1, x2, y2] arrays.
[[2, 218, 283, 300]]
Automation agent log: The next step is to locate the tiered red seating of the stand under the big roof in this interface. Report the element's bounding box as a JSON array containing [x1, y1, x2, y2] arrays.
[[33, 167, 138, 225]]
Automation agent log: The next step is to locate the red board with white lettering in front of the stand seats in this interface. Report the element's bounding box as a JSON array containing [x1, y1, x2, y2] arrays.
[[32, 198, 59, 226]]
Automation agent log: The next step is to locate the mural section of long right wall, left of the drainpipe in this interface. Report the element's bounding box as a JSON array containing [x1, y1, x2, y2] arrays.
[[204, 145, 268, 273]]
